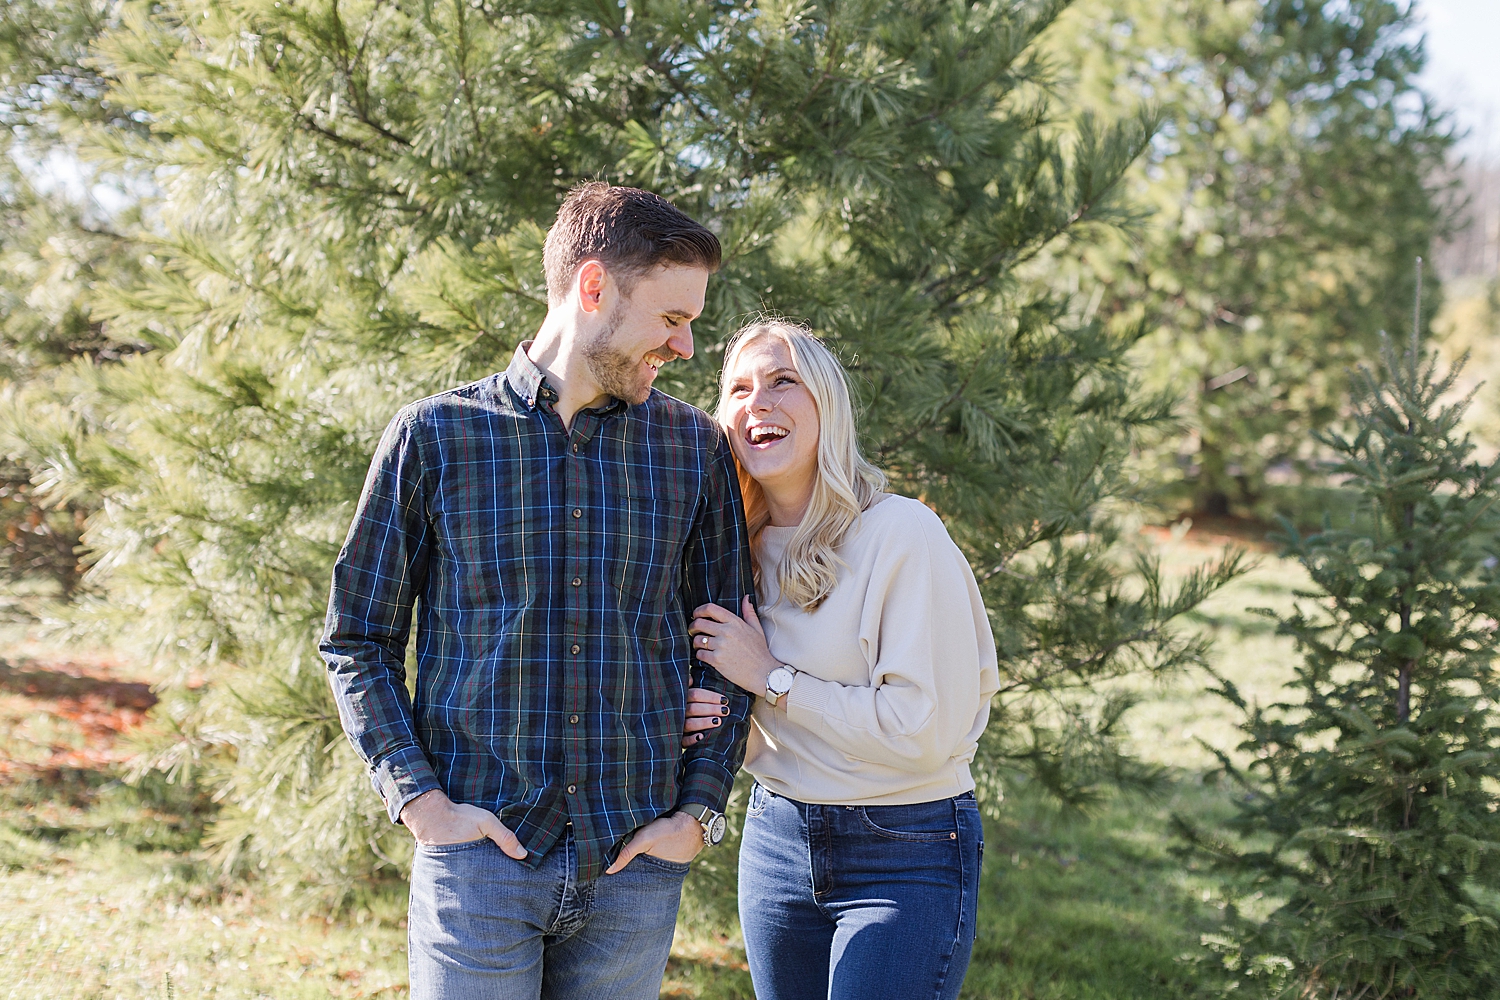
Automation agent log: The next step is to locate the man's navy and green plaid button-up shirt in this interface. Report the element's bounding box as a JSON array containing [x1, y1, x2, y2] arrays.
[[321, 345, 755, 879]]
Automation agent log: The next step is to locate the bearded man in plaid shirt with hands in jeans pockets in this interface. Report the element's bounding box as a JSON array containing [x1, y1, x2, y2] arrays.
[[321, 183, 753, 1000]]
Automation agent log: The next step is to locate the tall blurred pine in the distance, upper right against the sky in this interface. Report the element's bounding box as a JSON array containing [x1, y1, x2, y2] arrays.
[[1056, 0, 1454, 516]]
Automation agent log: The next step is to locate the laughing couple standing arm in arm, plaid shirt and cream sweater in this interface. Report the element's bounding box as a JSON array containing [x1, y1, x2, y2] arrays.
[[321, 183, 999, 1000]]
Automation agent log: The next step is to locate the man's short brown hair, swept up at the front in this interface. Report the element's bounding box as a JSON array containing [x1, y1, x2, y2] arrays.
[[543, 180, 723, 303]]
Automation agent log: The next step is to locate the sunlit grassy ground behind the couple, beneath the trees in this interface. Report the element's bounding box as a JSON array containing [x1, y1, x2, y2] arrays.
[[0, 537, 1299, 1000]]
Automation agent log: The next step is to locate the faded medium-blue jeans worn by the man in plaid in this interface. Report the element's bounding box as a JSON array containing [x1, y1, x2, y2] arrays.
[[407, 831, 689, 1000]]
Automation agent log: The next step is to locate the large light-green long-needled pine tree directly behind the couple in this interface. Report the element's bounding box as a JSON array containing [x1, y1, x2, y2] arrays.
[[11, 0, 1235, 886]]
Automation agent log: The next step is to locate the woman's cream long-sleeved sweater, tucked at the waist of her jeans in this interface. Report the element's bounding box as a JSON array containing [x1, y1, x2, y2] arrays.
[[746, 495, 1001, 805]]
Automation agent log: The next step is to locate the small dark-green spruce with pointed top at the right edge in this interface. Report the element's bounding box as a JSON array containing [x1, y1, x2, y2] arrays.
[[1179, 268, 1500, 1000]]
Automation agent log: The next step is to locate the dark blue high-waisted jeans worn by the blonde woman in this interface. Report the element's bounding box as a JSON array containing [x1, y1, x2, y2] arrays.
[[740, 783, 984, 1000]]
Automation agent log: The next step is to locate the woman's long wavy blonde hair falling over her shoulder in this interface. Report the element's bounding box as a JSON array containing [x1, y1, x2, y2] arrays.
[[716, 318, 885, 612]]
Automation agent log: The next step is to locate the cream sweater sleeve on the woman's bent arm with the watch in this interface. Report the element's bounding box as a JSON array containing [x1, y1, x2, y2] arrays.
[[785, 511, 999, 772]]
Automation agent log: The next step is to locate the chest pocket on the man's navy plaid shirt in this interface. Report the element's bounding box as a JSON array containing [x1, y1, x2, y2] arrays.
[[608, 495, 695, 618]]
